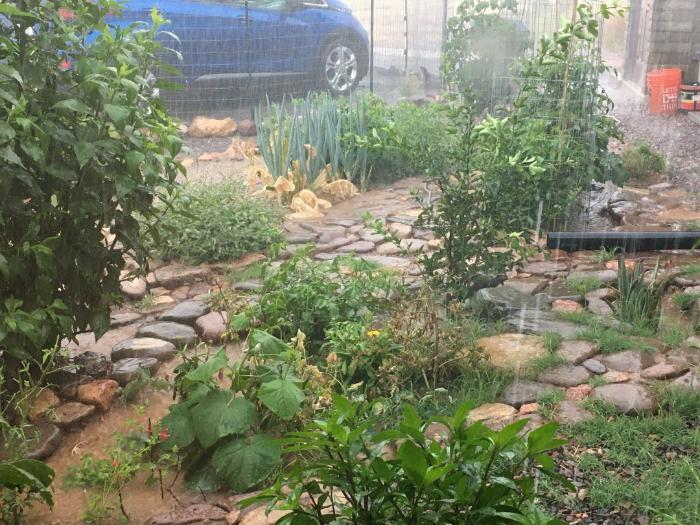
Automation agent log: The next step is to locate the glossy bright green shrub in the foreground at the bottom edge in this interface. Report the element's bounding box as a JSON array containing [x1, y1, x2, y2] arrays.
[[243, 398, 566, 525]]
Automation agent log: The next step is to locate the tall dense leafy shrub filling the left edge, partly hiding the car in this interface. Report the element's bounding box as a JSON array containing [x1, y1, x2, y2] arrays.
[[0, 0, 184, 363]]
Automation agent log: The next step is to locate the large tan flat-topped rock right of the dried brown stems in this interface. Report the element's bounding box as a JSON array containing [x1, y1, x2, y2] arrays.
[[476, 334, 547, 371]]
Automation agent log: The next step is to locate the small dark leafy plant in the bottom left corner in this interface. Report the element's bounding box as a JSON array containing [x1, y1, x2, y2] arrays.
[[0, 459, 54, 525]]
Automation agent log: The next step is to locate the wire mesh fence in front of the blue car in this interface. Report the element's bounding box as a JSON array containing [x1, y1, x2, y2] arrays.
[[150, 0, 620, 120]]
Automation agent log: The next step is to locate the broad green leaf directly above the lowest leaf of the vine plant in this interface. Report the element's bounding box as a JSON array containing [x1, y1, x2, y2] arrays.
[[190, 390, 257, 448]]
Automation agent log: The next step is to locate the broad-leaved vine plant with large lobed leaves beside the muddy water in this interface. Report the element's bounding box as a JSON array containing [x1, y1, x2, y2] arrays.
[[161, 330, 321, 492]]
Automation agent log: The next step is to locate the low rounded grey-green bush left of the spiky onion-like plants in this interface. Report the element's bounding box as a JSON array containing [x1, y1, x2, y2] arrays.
[[152, 180, 284, 263]]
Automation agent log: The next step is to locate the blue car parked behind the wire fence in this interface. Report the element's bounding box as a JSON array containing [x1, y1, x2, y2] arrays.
[[110, 0, 369, 95]]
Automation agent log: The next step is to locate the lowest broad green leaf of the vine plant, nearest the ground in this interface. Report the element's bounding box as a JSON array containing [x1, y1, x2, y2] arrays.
[[211, 434, 280, 492]]
